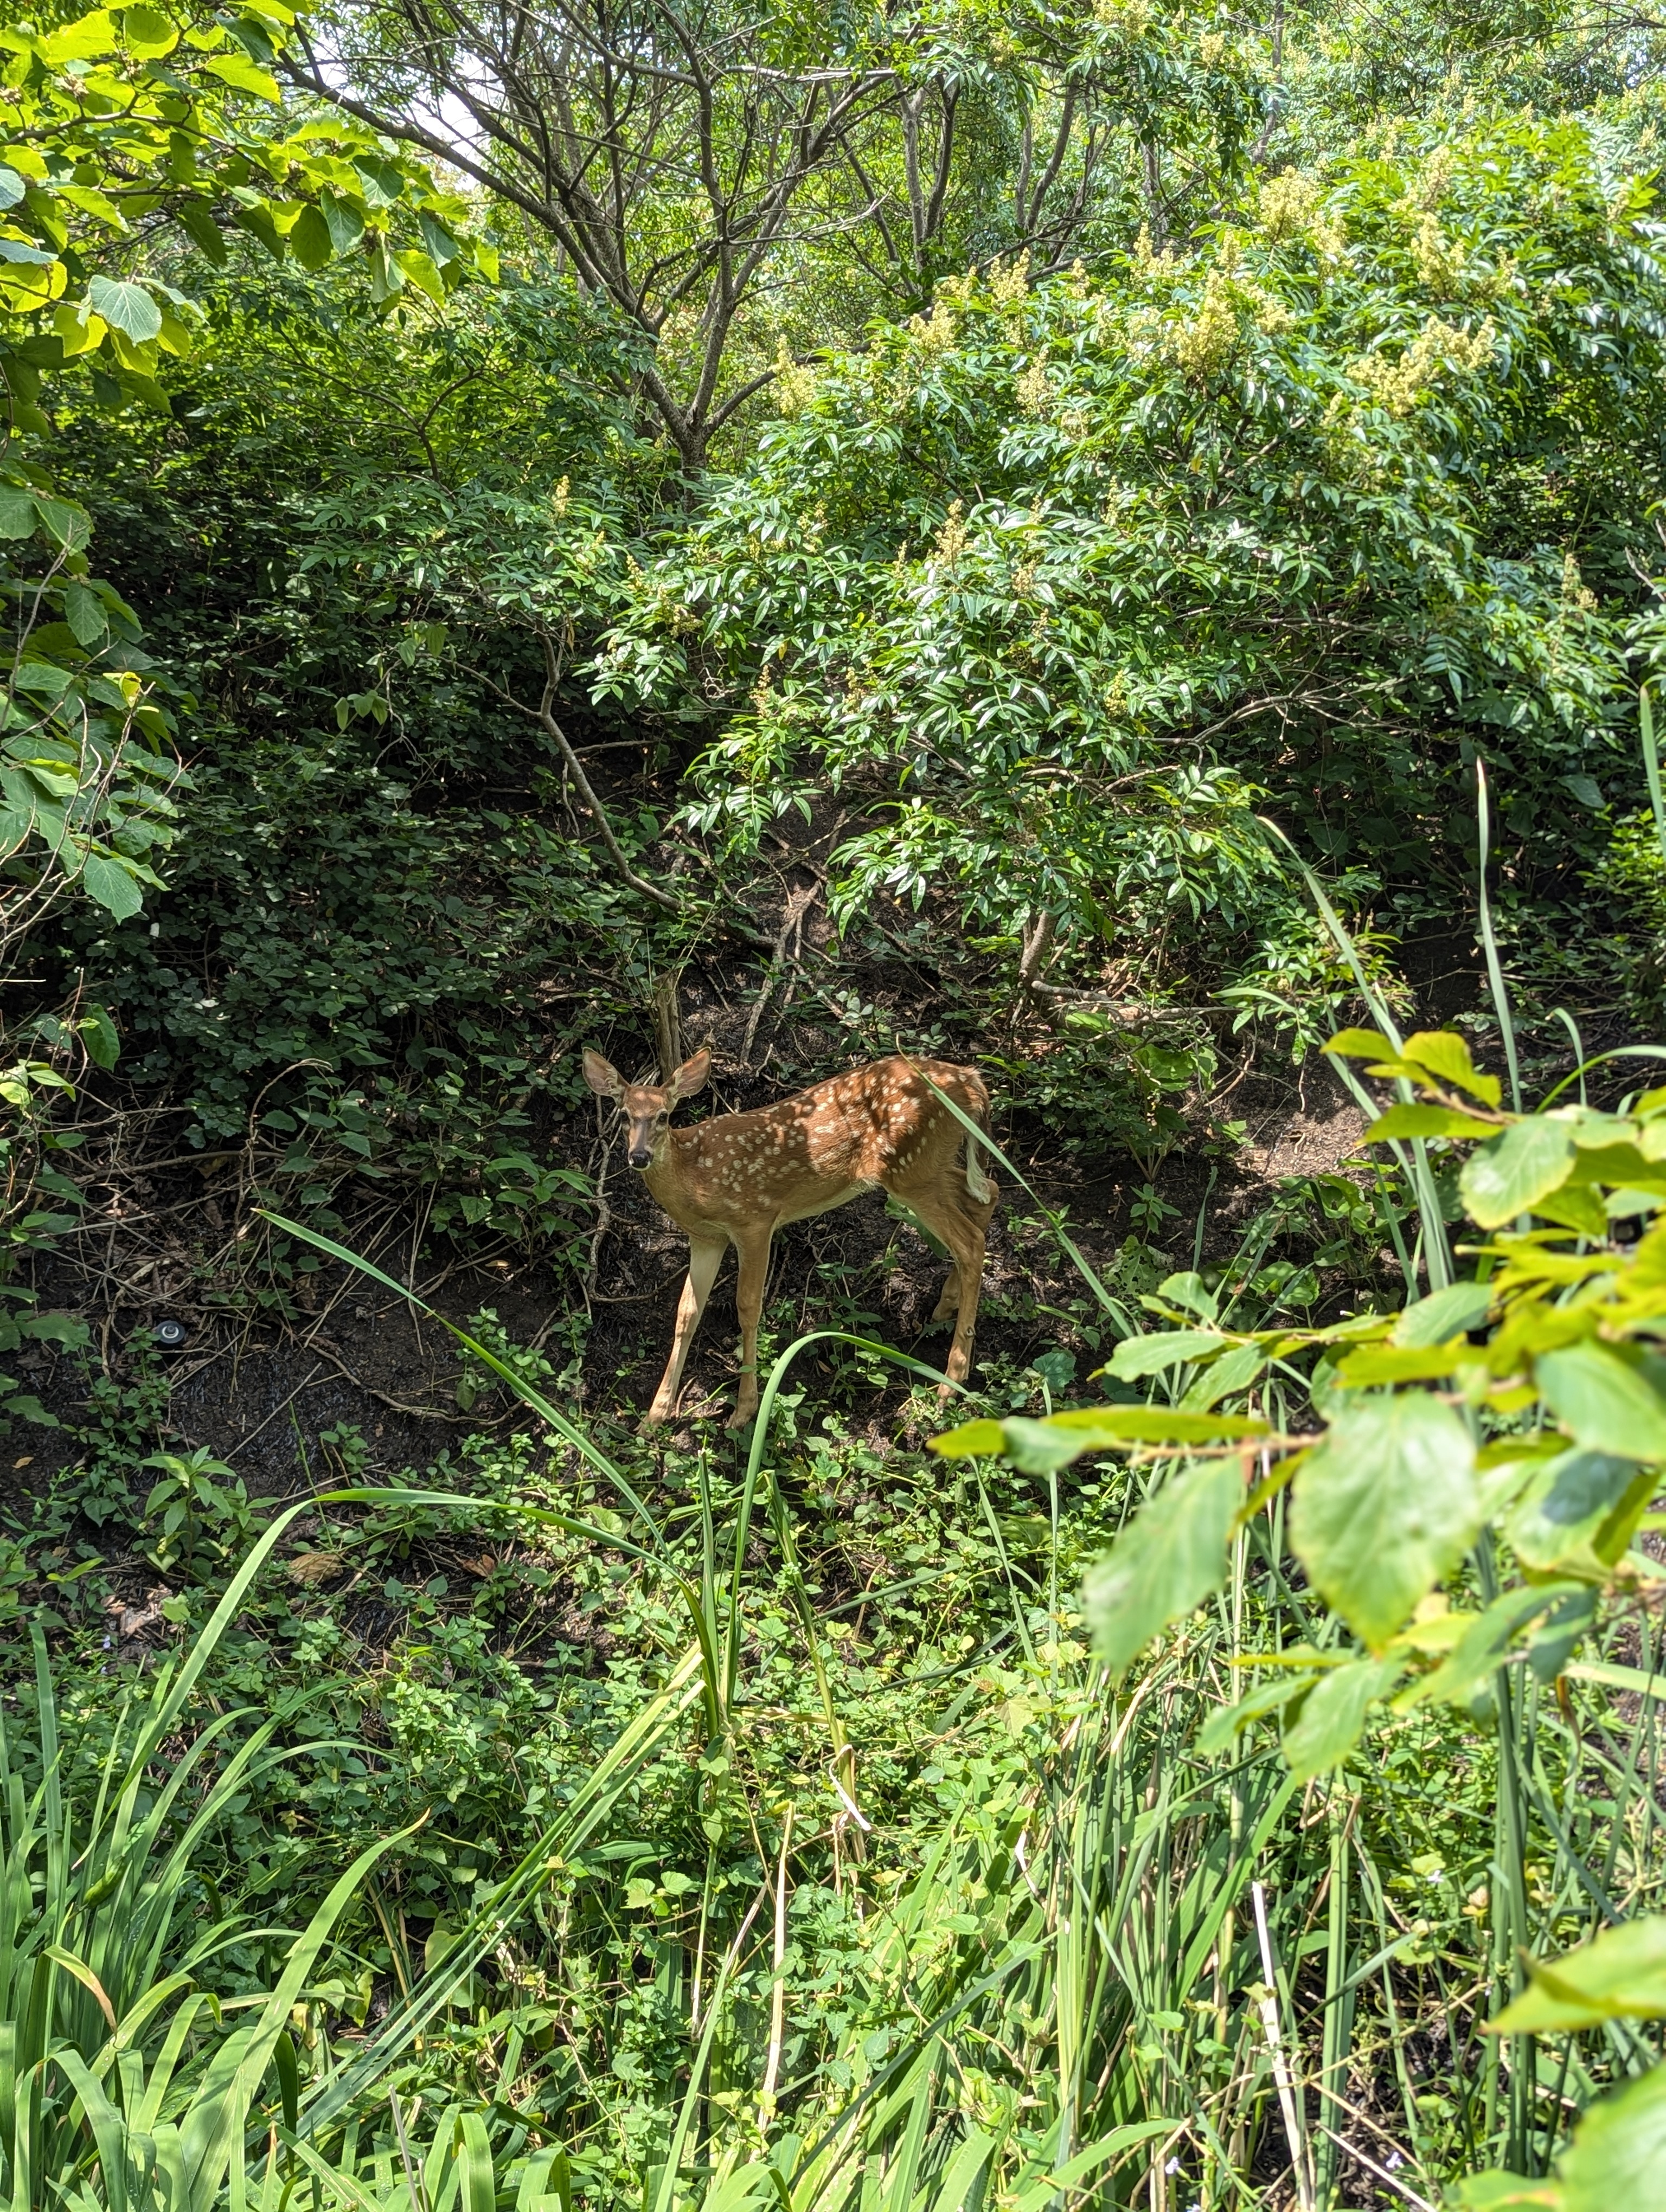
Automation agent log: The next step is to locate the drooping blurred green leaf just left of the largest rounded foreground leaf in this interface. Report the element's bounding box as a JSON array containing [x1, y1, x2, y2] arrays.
[[1082, 1460, 1244, 1675]]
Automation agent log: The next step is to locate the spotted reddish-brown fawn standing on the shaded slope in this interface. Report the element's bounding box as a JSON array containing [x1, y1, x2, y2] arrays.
[[584, 1051, 996, 1429]]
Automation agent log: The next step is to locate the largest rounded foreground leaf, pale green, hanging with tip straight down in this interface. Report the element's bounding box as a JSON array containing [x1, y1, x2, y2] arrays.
[[1290, 1391, 1482, 1650]]
